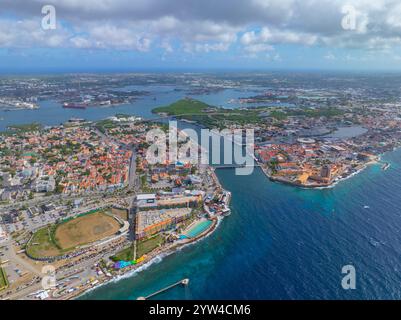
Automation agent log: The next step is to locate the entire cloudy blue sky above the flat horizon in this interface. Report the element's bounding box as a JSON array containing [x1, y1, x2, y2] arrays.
[[0, 0, 401, 73]]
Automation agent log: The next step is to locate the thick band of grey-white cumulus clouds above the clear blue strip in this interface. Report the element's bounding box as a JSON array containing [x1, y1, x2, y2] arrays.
[[0, 0, 401, 53]]
